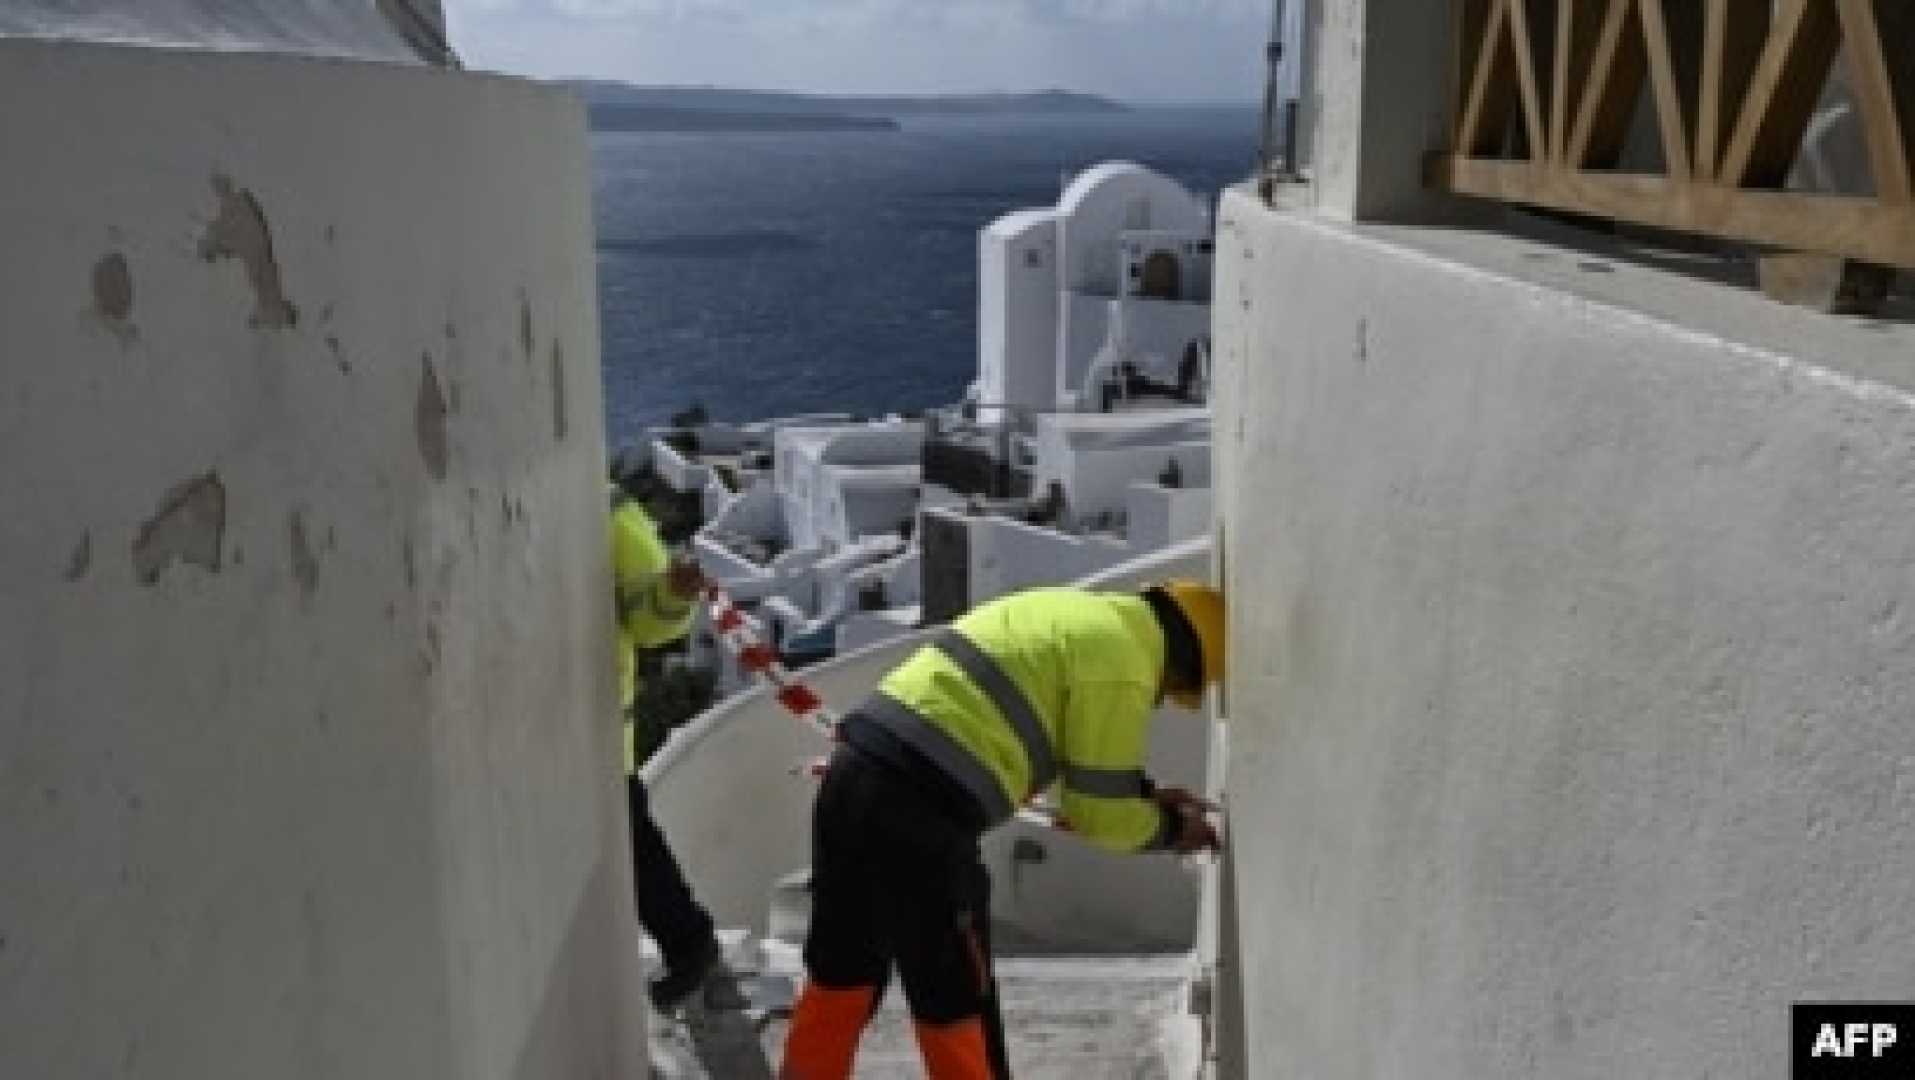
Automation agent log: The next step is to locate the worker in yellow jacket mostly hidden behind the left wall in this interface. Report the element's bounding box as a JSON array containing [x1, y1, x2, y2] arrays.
[[611, 484, 722, 1013]]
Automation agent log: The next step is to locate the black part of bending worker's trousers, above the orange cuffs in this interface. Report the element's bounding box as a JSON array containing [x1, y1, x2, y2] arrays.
[[804, 747, 1011, 1078]]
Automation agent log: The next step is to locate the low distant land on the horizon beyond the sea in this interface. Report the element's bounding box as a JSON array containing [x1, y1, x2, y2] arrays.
[[563, 80, 1128, 132]]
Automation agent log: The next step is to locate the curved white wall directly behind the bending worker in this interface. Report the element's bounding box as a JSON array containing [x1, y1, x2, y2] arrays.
[[645, 540, 1210, 952]]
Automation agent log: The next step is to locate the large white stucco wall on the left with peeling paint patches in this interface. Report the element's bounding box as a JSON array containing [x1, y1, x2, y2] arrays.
[[0, 42, 645, 1080]]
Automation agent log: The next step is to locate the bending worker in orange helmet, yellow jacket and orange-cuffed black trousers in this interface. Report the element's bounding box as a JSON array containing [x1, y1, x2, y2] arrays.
[[783, 582, 1224, 1080]]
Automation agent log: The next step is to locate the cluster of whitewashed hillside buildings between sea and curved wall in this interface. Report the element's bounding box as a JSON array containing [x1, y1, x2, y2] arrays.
[[647, 163, 1212, 666]]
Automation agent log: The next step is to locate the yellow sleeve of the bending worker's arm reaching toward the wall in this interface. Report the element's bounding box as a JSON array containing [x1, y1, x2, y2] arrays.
[[1057, 682, 1180, 852]]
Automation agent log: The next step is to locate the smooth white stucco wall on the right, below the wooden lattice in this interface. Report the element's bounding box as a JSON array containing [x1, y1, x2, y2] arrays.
[[1216, 193, 1915, 1078]]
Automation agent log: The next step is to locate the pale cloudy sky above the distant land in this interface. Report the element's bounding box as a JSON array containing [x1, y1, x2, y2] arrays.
[[444, 0, 1270, 103]]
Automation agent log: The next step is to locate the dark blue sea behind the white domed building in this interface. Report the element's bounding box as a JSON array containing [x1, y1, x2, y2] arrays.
[[592, 107, 1258, 446]]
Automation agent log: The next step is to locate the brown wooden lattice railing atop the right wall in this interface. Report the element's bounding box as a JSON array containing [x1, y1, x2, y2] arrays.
[[1431, 0, 1915, 268]]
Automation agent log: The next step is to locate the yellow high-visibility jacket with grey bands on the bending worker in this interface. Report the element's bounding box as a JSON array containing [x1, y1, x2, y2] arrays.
[[860, 588, 1168, 852]]
